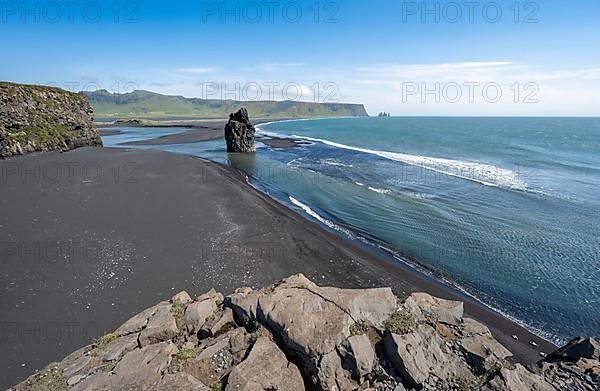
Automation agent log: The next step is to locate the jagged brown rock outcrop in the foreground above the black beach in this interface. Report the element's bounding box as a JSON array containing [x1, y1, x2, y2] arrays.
[[15, 275, 600, 391]]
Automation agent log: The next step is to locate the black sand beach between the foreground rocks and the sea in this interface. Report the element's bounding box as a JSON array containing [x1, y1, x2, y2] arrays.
[[0, 140, 554, 388]]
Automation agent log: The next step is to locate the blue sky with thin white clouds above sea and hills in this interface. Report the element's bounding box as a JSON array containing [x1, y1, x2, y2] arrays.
[[0, 0, 600, 115]]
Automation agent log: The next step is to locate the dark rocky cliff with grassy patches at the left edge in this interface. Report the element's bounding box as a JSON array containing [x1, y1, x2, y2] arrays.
[[0, 83, 102, 158]]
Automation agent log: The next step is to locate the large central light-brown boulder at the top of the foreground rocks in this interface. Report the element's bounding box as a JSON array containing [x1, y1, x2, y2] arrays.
[[230, 275, 396, 389]]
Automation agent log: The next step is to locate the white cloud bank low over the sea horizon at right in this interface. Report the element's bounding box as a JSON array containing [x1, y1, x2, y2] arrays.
[[338, 61, 600, 115]]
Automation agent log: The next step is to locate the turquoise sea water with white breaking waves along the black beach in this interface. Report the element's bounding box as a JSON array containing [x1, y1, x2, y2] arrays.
[[105, 117, 600, 342]]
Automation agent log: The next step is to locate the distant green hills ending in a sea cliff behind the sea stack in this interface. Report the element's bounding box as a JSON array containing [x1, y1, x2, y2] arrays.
[[82, 90, 368, 118]]
